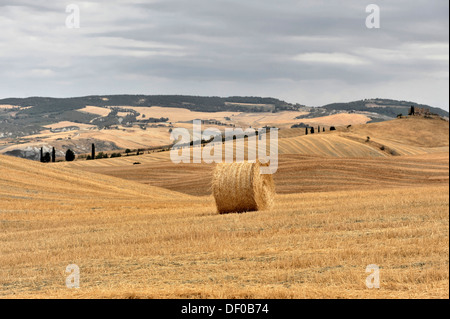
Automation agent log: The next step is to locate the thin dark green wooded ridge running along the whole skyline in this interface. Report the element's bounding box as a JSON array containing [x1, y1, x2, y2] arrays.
[[0, 94, 449, 120]]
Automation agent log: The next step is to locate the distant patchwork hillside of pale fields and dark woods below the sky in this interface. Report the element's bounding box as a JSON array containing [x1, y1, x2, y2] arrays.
[[0, 95, 448, 160]]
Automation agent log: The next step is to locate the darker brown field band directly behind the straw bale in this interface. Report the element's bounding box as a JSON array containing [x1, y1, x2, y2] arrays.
[[64, 152, 449, 196]]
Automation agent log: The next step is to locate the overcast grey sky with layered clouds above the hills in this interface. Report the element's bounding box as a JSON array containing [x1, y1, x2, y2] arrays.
[[0, 0, 449, 110]]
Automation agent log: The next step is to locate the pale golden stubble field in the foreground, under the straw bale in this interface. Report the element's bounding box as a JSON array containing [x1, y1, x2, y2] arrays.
[[0, 148, 449, 298]]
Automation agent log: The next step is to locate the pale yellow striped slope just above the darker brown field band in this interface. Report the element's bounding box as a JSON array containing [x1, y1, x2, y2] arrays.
[[59, 117, 449, 167]]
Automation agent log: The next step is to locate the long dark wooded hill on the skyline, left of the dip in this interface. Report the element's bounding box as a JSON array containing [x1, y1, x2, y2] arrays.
[[0, 95, 297, 139]]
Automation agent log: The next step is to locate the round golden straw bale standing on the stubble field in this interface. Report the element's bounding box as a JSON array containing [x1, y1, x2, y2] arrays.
[[212, 162, 275, 214]]
